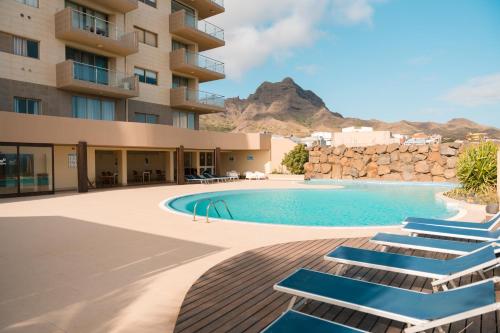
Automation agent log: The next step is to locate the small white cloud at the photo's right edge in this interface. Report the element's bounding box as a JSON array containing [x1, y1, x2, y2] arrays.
[[444, 73, 500, 107]]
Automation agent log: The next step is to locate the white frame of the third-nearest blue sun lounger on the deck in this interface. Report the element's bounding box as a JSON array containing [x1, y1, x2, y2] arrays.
[[324, 244, 500, 291]]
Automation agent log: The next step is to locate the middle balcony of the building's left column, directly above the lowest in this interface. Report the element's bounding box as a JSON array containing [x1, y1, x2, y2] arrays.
[[56, 8, 139, 56]]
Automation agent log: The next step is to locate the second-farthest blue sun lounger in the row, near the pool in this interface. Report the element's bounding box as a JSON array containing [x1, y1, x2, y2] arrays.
[[403, 223, 500, 242]]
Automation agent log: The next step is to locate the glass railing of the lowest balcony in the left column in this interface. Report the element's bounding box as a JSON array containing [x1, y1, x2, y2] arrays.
[[72, 61, 135, 90]]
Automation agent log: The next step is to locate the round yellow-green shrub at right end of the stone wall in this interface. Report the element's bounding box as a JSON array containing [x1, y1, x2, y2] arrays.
[[457, 142, 498, 194]]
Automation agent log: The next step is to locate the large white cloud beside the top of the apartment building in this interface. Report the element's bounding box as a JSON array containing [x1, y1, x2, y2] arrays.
[[208, 0, 377, 79]]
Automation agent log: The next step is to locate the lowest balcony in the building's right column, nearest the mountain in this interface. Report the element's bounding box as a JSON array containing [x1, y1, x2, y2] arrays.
[[170, 87, 225, 113]]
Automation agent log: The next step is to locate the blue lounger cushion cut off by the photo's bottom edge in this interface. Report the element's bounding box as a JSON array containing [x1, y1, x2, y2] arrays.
[[262, 310, 365, 333]]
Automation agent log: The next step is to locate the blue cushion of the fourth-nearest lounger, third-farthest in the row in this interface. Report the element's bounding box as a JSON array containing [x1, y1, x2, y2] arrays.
[[370, 232, 492, 255]]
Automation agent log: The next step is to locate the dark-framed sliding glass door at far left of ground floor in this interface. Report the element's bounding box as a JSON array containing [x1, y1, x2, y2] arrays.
[[0, 143, 54, 197]]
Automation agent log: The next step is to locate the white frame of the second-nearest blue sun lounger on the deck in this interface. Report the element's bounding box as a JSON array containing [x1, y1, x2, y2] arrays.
[[274, 273, 500, 333]]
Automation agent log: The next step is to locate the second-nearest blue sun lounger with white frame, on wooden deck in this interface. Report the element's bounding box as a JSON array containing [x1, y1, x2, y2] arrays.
[[274, 269, 500, 333]]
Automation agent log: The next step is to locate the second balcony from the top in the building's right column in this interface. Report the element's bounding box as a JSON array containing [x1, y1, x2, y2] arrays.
[[170, 10, 225, 51]]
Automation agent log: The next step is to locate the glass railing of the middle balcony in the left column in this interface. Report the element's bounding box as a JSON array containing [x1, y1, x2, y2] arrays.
[[71, 8, 125, 40]]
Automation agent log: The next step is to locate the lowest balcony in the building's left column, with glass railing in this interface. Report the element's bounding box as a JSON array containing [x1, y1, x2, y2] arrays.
[[56, 60, 139, 98]]
